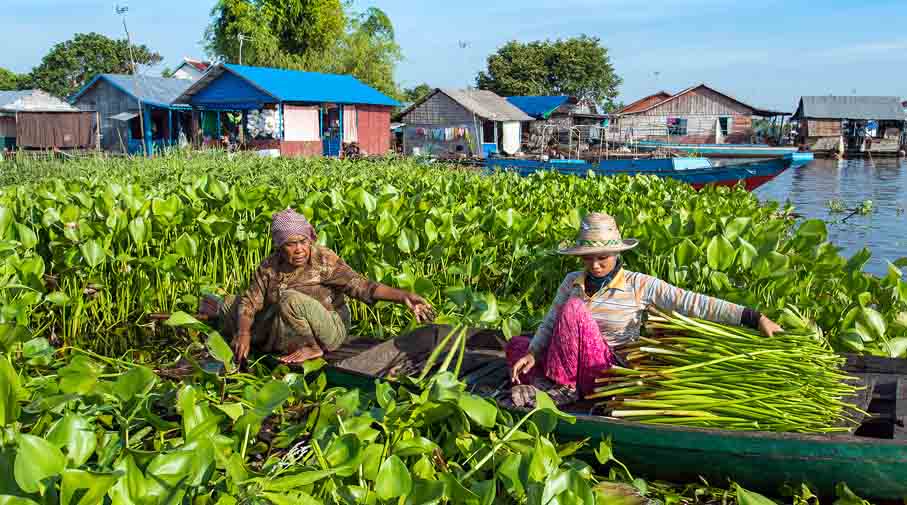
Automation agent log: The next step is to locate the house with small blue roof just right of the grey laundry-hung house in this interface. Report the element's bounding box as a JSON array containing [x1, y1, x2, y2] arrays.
[[507, 95, 608, 152]]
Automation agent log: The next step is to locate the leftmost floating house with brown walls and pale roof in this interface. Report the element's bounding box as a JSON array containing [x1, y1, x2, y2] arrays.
[[0, 89, 97, 152]]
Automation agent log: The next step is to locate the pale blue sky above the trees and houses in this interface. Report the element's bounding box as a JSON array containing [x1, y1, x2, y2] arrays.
[[0, 0, 907, 110]]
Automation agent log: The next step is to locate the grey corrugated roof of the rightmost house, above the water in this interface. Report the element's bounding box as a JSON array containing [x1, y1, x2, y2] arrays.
[[794, 96, 907, 121]]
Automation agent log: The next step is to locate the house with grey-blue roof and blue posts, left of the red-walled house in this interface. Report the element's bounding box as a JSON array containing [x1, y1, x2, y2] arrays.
[[70, 74, 192, 156]]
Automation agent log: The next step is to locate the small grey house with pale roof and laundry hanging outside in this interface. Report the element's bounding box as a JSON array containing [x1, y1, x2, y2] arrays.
[[395, 88, 533, 157]]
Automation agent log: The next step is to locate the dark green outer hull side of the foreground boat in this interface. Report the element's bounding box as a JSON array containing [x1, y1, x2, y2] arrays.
[[326, 367, 907, 500]]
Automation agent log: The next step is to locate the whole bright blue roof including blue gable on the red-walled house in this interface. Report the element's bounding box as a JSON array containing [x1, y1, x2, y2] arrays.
[[181, 64, 400, 107]]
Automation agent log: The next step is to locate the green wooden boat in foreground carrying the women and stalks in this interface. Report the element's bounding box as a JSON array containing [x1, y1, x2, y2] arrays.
[[326, 326, 907, 500]]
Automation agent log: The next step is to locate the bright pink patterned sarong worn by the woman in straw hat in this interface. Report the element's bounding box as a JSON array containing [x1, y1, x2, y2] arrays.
[[504, 298, 613, 394]]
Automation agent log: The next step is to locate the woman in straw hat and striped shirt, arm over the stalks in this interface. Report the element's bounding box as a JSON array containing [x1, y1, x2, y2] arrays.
[[506, 213, 781, 406]]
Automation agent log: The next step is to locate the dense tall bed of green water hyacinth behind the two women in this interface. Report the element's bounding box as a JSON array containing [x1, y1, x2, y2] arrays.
[[0, 153, 907, 356]]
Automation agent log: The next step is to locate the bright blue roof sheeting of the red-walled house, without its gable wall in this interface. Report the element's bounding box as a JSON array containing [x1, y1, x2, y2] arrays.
[[179, 64, 400, 107]]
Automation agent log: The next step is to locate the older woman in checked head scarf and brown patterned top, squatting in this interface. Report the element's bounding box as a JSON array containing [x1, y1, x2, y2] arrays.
[[203, 209, 434, 363]]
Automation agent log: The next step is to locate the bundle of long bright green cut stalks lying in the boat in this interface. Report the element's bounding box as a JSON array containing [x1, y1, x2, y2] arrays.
[[587, 313, 865, 433]]
